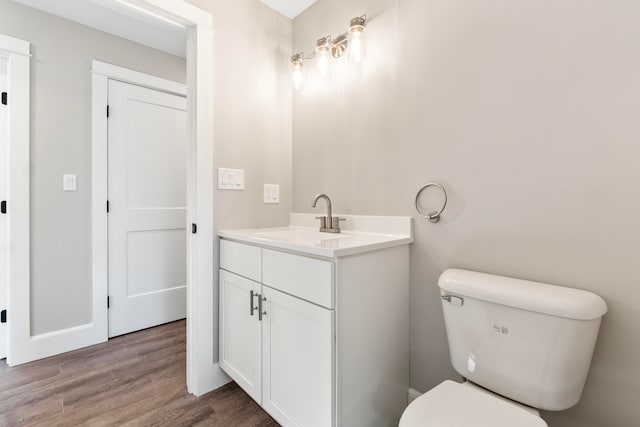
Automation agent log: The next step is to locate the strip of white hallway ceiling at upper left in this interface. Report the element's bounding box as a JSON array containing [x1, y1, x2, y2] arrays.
[[14, 0, 187, 58]]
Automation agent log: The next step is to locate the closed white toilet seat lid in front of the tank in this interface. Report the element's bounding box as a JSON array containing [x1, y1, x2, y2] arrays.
[[398, 380, 547, 427]]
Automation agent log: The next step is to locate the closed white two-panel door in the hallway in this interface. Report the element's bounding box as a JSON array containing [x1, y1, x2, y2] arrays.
[[108, 80, 187, 337]]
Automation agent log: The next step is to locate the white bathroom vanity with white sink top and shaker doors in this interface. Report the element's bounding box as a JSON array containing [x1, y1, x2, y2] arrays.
[[218, 214, 412, 427]]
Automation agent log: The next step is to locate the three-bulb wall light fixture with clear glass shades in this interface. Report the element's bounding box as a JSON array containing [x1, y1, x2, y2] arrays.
[[291, 15, 367, 89]]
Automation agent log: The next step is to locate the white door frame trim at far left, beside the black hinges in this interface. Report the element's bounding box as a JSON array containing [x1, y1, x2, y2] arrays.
[[0, 34, 31, 364]]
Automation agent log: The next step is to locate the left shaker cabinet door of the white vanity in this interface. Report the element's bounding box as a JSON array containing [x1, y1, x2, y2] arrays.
[[220, 270, 262, 403]]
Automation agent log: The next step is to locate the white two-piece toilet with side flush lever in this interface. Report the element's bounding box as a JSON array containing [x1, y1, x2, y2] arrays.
[[399, 269, 607, 427]]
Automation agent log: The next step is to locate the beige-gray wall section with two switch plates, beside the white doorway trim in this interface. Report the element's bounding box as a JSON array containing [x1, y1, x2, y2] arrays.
[[188, 0, 292, 230]]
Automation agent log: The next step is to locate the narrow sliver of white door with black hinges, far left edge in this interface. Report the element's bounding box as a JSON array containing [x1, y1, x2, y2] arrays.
[[0, 58, 9, 359]]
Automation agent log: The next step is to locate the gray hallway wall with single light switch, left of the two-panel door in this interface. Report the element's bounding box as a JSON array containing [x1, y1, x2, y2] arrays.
[[0, 0, 186, 335]]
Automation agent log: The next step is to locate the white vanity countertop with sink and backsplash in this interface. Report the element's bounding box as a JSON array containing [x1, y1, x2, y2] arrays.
[[218, 213, 413, 258]]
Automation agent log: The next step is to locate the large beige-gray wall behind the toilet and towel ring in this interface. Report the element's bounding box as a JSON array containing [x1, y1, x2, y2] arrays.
[[293, 0, 640, 427]]
